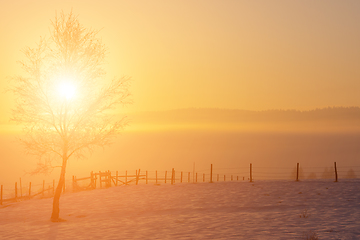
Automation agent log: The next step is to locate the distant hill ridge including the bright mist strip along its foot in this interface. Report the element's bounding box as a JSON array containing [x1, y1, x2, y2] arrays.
[[129, 107, 360, 132]]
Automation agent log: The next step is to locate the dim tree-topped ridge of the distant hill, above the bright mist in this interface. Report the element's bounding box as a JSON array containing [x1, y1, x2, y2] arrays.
[[134, 107, 360, 123]]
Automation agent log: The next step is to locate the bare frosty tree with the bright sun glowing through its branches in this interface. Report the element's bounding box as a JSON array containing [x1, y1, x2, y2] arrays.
[[11, 12, 131, 222]]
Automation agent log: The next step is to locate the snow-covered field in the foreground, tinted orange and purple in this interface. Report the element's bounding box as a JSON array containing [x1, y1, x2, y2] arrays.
[[0, 179, 360, 239]]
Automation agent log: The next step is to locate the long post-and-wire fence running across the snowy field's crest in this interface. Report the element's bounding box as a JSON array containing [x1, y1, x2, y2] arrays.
[[0, 162, 360, 205]]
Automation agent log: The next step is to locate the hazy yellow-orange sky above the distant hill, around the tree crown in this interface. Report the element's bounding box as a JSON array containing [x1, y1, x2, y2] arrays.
[[0, 0, 360, 123]]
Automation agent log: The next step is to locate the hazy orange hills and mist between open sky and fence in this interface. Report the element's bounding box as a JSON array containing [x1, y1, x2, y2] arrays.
[[0, 107, 360, 186]]
